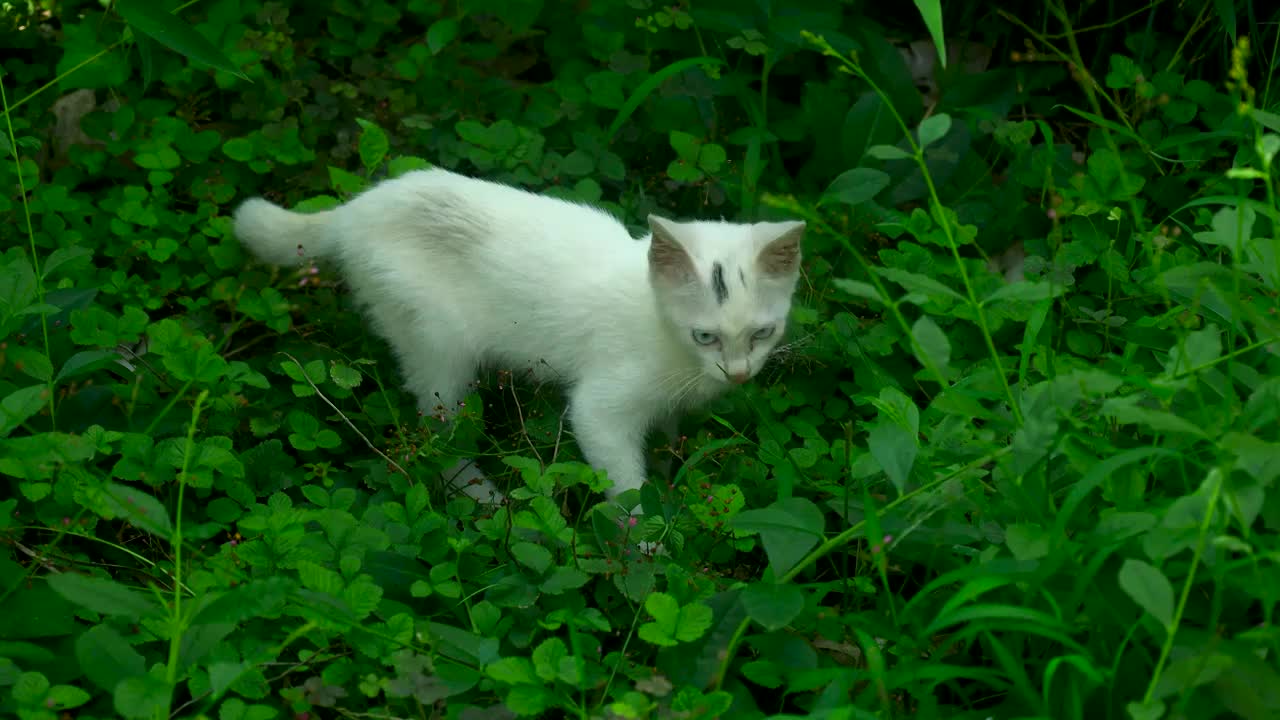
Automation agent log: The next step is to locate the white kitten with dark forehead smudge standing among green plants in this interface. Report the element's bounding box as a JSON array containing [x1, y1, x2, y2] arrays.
[[236, 169, 805, 509]]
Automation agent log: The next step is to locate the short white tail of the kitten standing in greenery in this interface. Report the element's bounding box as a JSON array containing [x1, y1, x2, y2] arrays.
[[234, 197, 334, 265]]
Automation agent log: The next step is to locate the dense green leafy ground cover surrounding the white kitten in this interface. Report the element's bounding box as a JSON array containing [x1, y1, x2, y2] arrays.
[[0, 0, 1280, 720]]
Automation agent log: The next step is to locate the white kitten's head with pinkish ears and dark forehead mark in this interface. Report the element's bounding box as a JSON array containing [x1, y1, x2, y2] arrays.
[[649, 215, 805, 383]]
